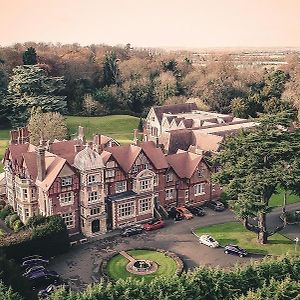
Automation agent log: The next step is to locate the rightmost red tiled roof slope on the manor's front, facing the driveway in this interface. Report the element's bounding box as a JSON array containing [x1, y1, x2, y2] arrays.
[[166, 152, 203, 178]]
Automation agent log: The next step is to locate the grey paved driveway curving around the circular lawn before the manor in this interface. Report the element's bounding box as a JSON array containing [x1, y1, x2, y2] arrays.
[[51, 204, 300, 289]]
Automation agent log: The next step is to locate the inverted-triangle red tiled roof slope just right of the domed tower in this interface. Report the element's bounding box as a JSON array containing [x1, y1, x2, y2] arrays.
[[105, 145, 141, 173]]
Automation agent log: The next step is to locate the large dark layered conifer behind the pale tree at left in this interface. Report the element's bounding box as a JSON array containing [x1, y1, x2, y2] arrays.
[[6, 65, 66, 125]]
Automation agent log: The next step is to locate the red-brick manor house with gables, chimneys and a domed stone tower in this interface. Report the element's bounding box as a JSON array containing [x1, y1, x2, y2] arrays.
[[3, 105, 252, 237]]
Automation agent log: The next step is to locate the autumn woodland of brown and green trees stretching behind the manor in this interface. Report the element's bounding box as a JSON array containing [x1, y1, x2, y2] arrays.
[[0, 43, 300, 125]]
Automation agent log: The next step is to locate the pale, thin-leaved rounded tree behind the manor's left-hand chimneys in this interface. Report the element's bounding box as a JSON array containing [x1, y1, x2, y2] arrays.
[[28, 108, 67, 145]]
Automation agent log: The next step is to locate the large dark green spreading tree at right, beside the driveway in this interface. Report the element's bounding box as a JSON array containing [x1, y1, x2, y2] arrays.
[[213, 113, 300, 244]]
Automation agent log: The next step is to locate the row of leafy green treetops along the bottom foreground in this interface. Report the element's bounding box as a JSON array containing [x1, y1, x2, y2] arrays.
[[0, 257, 300, 300]]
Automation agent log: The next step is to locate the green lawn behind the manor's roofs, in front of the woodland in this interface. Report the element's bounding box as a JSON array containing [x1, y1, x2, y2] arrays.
[[66, 115, 139, 144]]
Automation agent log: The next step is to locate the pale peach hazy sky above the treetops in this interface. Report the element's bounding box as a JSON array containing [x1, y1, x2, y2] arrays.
[[0, 0, 300, 48]]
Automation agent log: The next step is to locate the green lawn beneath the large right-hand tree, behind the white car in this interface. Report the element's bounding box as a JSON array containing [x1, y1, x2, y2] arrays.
[[195, 222, 300, 255]]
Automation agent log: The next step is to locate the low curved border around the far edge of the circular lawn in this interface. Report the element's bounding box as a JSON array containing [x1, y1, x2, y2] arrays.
[[99, 247, 184, 281]]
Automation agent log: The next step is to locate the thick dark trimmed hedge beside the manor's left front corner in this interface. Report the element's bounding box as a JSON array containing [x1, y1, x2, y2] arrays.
[[0, 216, 70, 259]]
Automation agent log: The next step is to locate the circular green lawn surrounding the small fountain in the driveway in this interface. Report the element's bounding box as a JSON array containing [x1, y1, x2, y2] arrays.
[[107, 250, 177, 282]]
